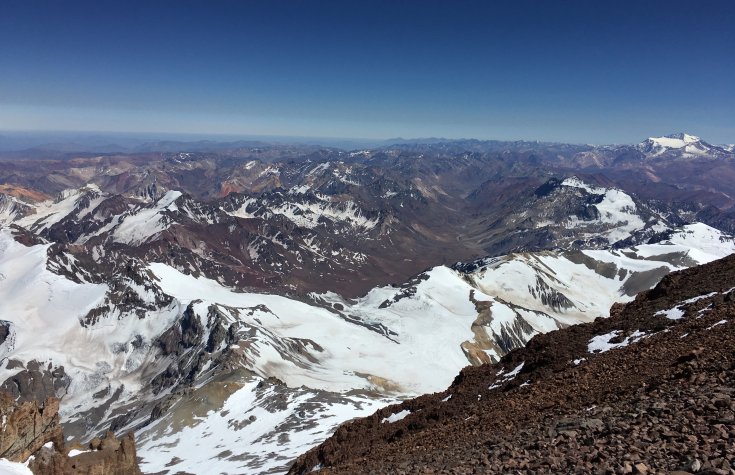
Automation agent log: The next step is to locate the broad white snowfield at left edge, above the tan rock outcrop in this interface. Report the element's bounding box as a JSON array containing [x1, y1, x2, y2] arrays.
[[0, 229, 180, 408]]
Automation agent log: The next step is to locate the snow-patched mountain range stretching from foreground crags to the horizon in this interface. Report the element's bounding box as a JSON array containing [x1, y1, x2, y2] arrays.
[[0, 134, 735, 474]]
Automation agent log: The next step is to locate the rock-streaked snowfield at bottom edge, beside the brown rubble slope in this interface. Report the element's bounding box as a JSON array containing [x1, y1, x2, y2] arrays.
[[137, 380, 393, 473]]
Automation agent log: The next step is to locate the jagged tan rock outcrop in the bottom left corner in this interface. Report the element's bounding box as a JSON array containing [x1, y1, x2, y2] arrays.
[[0, 392, 142, 475]]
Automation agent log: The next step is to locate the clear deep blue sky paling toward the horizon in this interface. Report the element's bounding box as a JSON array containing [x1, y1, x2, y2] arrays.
[[0, 0, 735, 143]]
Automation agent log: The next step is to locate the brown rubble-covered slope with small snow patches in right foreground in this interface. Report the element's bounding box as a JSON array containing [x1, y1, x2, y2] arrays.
[[290, 255, 735, 474]]
